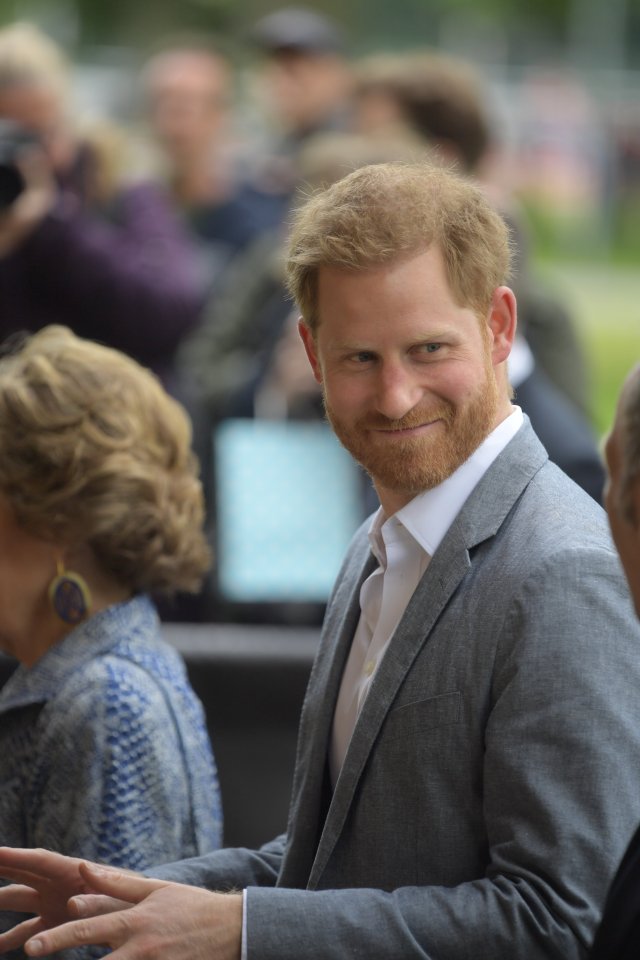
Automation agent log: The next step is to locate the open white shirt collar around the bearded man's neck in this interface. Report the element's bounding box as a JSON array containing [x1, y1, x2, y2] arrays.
[[369, 405, 524, 569]]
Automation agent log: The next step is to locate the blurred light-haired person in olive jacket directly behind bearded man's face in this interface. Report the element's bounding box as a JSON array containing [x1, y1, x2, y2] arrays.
[[177, 132, 425, 523]]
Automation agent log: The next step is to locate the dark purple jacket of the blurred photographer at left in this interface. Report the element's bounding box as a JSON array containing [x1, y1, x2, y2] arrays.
[[0, 144, 204, 388]]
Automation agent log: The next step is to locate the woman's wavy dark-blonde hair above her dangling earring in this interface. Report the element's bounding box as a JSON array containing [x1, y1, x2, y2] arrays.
[[0, 326, 210, 593]]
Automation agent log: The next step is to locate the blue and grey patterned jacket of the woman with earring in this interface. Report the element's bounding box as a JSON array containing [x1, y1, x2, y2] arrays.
[[0, 596, 222, 952]]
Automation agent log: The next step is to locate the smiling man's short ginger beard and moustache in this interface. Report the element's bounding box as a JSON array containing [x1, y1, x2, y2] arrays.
[[325, 364, 499, 499]]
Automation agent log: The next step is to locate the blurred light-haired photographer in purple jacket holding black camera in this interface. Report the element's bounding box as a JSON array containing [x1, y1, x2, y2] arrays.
[[0, 23, 205, 388]]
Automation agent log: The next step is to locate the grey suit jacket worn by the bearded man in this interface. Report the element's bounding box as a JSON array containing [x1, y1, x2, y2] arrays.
[[154, 424, 640, 960]]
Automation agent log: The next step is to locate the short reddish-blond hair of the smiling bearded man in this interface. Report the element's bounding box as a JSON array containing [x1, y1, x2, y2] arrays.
[[286, 161, 511, 331]]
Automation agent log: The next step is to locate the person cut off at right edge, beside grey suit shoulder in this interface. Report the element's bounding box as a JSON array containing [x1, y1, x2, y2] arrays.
[[590, 366, 640, 960]]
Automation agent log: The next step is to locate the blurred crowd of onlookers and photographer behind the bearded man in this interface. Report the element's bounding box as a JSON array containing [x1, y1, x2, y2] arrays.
[[0, 8, 603, 618]]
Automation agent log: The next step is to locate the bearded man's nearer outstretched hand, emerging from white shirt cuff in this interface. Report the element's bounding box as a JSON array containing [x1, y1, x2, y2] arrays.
[[7, 853, 242, 960]]
